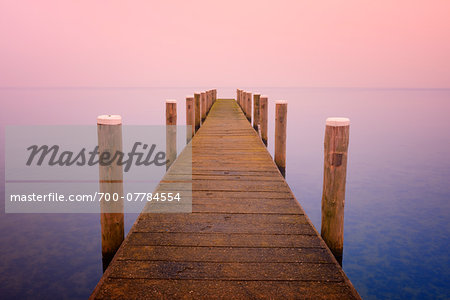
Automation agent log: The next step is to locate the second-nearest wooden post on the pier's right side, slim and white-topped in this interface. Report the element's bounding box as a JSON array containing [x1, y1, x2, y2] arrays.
[[275, 101, 287, 177]]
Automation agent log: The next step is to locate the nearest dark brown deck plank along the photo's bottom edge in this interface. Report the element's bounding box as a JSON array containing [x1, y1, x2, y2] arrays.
[[96, 278, 358, 300]]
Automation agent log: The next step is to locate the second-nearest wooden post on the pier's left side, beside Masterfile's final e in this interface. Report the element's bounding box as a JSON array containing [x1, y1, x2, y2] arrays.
[[166, 100, 177, 170]]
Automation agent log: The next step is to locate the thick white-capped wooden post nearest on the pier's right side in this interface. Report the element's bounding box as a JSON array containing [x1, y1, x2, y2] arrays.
[[321, 118, 350, 264]]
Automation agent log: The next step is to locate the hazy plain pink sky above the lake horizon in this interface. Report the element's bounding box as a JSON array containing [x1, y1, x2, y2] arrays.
[[0, 0, 450, 88]]
